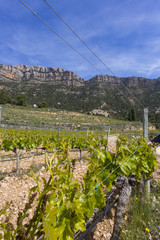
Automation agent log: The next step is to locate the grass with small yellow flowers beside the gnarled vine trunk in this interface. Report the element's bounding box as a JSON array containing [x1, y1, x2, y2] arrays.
[[121, 181, 160, 240]]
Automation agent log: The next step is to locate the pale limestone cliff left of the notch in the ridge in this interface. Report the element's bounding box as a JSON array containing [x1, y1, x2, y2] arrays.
[[0, 64, 84, 87]]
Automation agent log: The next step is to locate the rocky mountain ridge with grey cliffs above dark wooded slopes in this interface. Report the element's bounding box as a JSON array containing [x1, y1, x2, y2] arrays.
[[0, 64, 160, 118]]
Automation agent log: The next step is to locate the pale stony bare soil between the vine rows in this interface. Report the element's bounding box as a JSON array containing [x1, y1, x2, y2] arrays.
[[0, 136, 160, 240]]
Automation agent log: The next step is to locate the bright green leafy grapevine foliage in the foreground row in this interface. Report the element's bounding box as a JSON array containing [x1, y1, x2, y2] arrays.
[[0, 134, 156, 240]]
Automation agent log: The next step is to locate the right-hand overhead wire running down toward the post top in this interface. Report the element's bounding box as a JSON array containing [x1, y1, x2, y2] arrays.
[[43, 0, 144, 108]]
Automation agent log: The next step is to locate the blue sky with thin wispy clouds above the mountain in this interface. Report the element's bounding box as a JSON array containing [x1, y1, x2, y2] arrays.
[[0, 0, 160, 80]]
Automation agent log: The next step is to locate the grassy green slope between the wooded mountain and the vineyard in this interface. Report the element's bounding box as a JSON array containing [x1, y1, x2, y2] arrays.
[[2, 105, 154, 131]]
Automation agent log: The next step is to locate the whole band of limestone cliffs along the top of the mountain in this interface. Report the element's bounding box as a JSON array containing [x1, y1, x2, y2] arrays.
[[0, 64, 160, 87]]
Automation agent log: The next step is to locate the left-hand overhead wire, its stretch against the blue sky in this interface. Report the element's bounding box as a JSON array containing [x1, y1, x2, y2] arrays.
[[18, 0, 103, 74]]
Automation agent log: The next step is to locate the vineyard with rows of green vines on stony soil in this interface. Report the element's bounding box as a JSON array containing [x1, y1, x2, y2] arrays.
[[0, 126, 157, 240]]
